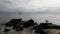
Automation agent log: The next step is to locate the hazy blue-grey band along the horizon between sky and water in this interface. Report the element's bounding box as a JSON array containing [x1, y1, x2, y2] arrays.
[[0, 11, 60, 14]]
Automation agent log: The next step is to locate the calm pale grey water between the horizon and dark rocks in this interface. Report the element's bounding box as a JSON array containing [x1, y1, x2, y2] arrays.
[[0, 14, 60, 25]]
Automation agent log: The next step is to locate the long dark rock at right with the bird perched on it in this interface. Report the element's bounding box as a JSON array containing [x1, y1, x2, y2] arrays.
[[35, 23, 60, 34]]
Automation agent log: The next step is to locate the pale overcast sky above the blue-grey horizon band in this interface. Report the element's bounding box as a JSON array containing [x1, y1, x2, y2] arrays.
[[0, 0, 60, 12]]
